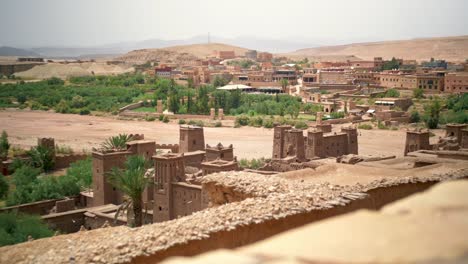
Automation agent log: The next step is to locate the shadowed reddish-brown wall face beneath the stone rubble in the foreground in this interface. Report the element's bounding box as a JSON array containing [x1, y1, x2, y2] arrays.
[[132, 182, 435, 263]]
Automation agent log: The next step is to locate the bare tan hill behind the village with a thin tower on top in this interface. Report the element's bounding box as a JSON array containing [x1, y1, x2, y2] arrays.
[[117, 43, 247, 63]]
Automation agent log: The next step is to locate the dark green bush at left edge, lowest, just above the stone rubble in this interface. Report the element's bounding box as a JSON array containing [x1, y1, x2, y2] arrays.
[[0, 212, 54, 246]]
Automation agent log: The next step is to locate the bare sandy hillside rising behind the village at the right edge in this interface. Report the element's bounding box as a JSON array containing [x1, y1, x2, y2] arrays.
[[283, 36, 468, 61]]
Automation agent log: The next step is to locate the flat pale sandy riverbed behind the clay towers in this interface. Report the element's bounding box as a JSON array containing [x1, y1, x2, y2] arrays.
[[0, 110, 443, 159]]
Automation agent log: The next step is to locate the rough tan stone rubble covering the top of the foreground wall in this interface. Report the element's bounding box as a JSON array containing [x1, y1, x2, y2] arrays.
[[0, 169, 468, 263]]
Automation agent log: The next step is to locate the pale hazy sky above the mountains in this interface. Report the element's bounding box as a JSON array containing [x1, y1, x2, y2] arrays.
[[0, 0, 468, 47]]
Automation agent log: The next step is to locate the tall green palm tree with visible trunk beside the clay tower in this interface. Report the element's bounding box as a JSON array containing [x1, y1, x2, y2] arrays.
[[108, 155, 149, 227]]
